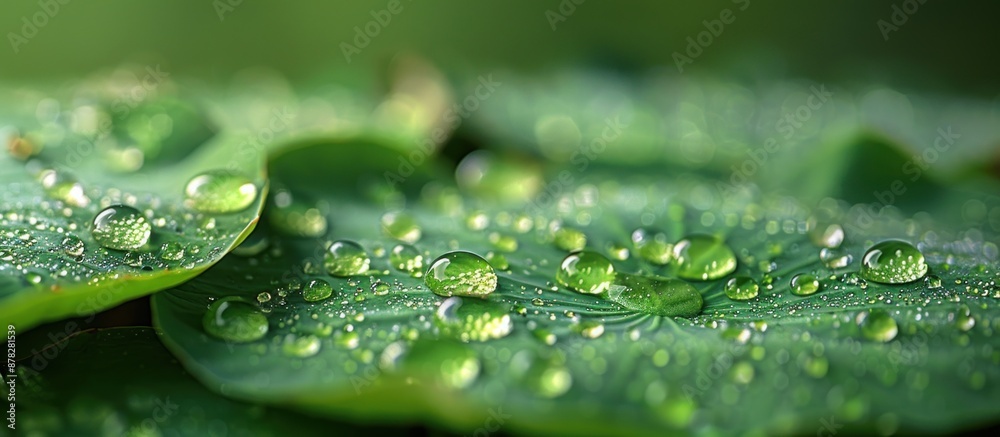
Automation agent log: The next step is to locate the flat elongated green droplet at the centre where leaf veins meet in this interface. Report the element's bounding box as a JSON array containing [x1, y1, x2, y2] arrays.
[[608, 273, 704, 317]]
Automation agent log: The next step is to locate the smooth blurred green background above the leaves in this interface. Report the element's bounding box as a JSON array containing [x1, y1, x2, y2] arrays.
[[0, 0, 1000, 100]]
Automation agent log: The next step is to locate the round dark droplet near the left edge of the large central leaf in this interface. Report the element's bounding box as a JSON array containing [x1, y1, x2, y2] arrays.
[[202, 297, 268, 343]]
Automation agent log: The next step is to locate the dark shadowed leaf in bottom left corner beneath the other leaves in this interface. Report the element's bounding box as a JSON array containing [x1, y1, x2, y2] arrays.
[[14, 328, 358, 437]]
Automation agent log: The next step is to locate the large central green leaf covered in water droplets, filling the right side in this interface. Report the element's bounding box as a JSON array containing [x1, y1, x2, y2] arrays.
[[152, 141, 1000, 435]]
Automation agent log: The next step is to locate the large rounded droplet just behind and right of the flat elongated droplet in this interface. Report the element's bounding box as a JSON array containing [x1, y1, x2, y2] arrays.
[[674, 235, 736, 280]]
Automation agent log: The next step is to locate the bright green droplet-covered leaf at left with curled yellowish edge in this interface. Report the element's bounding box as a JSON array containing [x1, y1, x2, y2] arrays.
[[0, 85, 267, 329]]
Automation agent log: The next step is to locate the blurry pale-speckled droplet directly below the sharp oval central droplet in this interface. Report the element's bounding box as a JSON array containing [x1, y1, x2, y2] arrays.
[[434, 296, 514, 342]]
